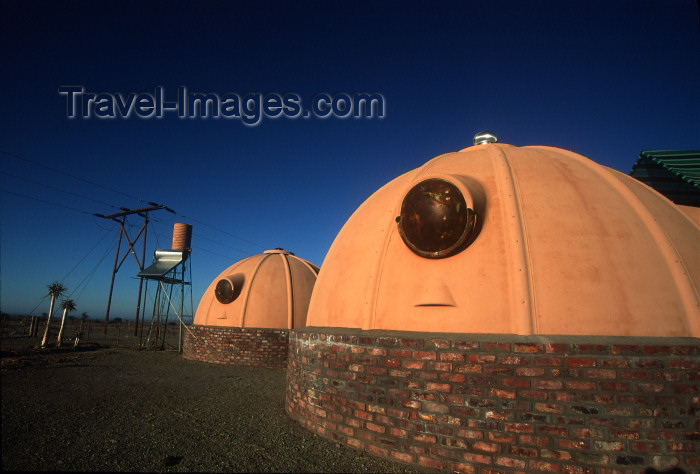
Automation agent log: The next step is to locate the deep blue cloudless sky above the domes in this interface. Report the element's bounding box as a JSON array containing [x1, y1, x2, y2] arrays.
[[0, 0, 700, 317]]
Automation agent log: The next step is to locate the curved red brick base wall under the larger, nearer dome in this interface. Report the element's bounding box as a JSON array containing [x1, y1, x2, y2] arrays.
[[286, 328, 700, 473]]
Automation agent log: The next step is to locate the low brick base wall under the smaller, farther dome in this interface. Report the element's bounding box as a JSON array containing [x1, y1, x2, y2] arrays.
[[182, 325, 289, 367]]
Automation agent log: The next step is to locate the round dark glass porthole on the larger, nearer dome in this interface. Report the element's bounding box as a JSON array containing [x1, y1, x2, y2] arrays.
[[396, 179, 476, 258]]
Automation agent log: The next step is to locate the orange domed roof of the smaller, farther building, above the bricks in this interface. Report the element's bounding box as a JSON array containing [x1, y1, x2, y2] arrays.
[[194, 249, 318, 329]]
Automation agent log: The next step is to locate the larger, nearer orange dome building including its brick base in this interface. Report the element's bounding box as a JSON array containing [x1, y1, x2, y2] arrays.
[[286, 134, 700, 473]]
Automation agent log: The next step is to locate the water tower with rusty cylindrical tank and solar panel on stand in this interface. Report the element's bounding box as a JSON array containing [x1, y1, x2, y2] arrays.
[[137, 222, 193, 350]]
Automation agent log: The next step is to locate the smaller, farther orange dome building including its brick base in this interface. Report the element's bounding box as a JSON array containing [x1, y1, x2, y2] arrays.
[[183, 249, 319, 367]]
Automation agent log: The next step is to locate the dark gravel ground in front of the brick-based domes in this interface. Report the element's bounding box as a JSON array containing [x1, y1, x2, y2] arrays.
[[0, 339, 425, 472]]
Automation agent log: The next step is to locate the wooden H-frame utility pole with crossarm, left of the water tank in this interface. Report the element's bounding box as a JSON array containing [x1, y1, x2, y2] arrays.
[[94, 202, 175, 335]]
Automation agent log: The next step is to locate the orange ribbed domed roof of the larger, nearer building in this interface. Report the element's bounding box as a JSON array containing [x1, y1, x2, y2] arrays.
[[307, 140, 700, 337]]
